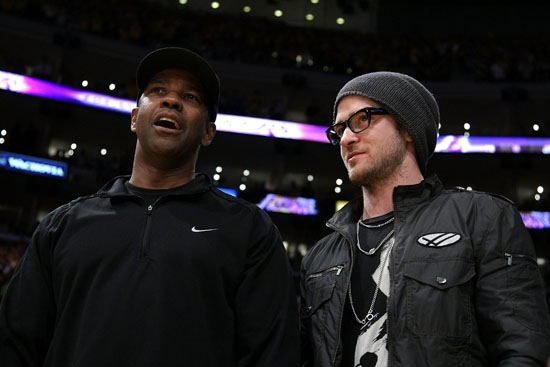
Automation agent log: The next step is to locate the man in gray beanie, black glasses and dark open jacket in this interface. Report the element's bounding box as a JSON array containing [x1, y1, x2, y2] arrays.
[[301, 72, 550, 367]]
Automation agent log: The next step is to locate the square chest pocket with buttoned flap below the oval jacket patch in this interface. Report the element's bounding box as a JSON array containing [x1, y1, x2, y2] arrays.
[[403, 259, 475, 338]]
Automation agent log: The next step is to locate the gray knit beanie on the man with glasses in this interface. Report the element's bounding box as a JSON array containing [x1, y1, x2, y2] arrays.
[[332, 71, 439, 174]]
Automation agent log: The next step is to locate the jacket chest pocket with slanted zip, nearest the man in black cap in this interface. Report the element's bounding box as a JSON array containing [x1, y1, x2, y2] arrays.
[[302, 265, 344, 343]]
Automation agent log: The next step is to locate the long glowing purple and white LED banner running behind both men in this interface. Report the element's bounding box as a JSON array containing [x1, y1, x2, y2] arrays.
[[0, 71, 550, 154]]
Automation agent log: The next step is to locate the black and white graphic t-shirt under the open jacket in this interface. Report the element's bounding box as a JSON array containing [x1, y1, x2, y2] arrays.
[[341, 213, 393, 367]]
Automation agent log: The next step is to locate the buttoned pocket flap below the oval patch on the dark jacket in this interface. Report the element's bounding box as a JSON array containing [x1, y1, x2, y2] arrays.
[[403, 259, 476, 289]]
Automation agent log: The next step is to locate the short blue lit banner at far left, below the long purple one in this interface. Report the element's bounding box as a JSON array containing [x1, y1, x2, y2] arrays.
[[0, 151, 67, 178]]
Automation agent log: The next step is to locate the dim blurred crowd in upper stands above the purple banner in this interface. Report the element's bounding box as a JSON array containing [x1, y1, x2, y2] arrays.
[[0, 0, 550, 87]]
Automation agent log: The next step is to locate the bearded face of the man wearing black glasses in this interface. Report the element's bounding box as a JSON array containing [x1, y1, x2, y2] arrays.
[[335, 95, 412, 186]]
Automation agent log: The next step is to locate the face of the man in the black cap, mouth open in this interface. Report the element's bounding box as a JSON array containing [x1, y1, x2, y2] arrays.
[[131, 69, 216, 162]]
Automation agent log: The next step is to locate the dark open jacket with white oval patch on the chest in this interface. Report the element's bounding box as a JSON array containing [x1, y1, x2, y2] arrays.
[[301, 176, 550, 367]]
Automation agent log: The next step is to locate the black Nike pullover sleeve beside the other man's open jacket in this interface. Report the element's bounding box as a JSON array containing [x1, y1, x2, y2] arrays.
[[235, 211, 300, 367]]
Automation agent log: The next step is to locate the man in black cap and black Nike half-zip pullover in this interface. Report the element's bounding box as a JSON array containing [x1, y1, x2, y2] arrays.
[[0, 48, 299, 367]]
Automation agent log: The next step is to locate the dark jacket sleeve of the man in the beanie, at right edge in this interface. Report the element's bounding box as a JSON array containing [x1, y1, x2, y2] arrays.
[[475, 202, 550, 367]]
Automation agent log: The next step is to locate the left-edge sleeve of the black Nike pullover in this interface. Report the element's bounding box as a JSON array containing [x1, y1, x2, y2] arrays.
[[0, 214, 56, 367]]
